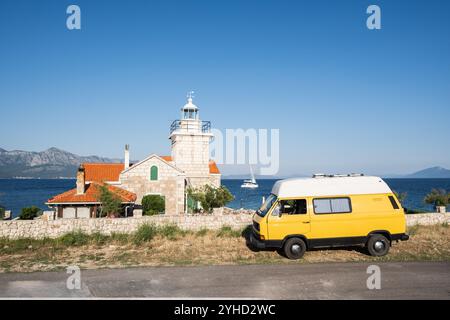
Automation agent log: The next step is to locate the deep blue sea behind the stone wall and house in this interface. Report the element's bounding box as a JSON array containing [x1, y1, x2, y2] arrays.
[[0, 179, 450, 217]]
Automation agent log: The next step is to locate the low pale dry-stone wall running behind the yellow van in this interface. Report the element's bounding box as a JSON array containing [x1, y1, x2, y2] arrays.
[[0, 212, 450, 239]]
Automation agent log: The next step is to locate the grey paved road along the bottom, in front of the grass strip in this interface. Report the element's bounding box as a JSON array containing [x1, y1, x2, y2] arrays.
[[0, 262, 450, 299]]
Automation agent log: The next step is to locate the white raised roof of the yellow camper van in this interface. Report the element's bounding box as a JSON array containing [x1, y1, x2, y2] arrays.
[[272, 175, 392, 198]]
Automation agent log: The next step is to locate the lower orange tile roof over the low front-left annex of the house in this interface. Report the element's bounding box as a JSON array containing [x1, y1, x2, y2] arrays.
[[47, 182, 136, 204]]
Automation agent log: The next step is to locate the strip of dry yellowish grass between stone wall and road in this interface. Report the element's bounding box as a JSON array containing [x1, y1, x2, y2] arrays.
[[0, 225, 450, 272]]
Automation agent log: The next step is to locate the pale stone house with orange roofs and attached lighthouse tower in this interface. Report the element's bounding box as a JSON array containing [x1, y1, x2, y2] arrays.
[[47, 96, 221, 218]]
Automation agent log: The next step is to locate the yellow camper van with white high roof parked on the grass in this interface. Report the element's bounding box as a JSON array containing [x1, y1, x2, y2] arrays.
[[250, 174, 409, 259]]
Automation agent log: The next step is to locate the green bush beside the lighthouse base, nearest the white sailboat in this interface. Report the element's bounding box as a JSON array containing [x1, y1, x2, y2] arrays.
[[188, 184, 234, 212]]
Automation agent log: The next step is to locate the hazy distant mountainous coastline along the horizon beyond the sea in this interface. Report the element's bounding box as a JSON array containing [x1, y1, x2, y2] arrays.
[[0, 147, 450, 179]]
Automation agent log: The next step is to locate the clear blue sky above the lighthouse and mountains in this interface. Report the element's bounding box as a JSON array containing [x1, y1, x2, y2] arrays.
[[0, 0, 450, 174]]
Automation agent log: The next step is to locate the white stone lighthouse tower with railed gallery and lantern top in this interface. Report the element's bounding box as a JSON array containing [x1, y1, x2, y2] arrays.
[[169, 91, 213, 187]]
